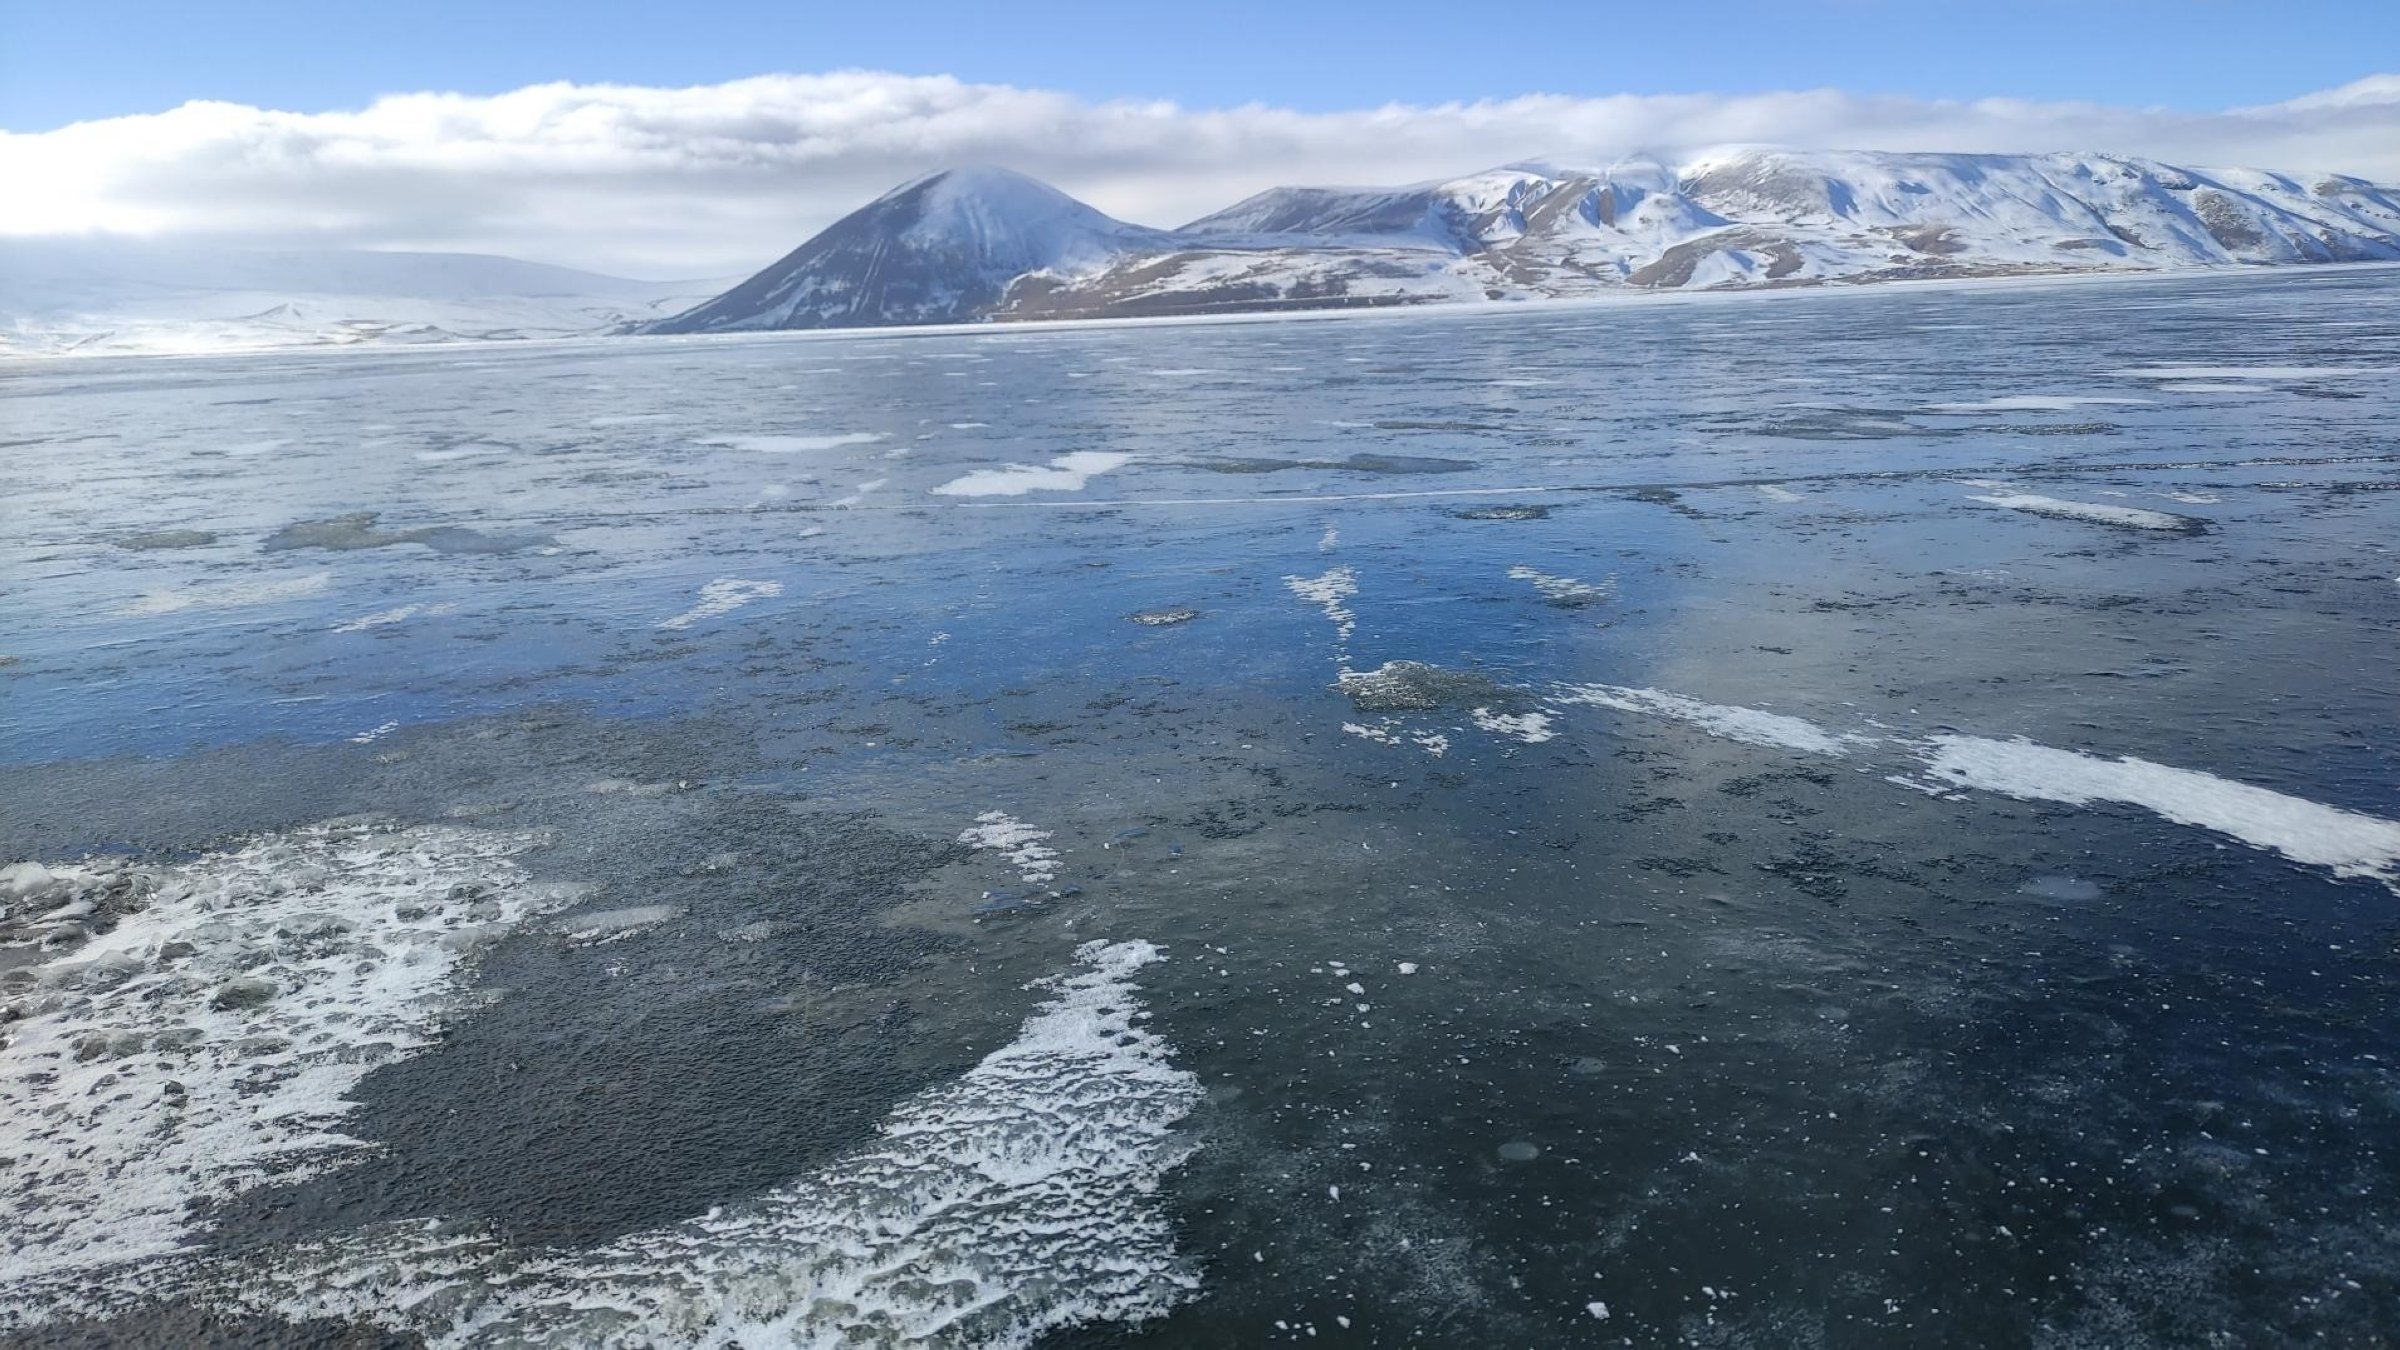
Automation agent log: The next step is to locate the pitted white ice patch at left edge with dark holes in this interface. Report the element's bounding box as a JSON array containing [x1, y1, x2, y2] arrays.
[[0, 824, 574, 1288]]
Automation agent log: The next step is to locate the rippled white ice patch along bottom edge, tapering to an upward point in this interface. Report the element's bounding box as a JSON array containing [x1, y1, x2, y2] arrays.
[[0, 942, 1202, 1350]]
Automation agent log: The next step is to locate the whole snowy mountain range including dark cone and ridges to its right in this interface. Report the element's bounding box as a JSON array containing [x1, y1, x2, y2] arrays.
[[646, 149, 2400, 331]]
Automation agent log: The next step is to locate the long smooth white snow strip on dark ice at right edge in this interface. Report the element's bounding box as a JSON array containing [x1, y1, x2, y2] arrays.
[[1927, 735, 2400, 884]]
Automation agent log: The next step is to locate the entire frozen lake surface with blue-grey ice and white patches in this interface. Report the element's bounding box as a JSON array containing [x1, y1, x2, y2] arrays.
[[0, 267, 2400, 1348]]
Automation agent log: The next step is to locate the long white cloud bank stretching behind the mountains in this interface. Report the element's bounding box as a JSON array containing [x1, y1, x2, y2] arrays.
[[0, 72, 2400, 276]]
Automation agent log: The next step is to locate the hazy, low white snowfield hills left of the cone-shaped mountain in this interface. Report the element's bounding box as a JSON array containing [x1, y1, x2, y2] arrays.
[[0, 238, 725, 356]]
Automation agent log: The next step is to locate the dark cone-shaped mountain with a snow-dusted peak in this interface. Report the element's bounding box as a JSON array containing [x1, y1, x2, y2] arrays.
[[646, 168, 1176, 334]]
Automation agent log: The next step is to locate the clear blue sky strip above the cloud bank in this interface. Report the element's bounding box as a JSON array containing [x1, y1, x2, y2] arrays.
[[0, 0, 2400, 132]]
